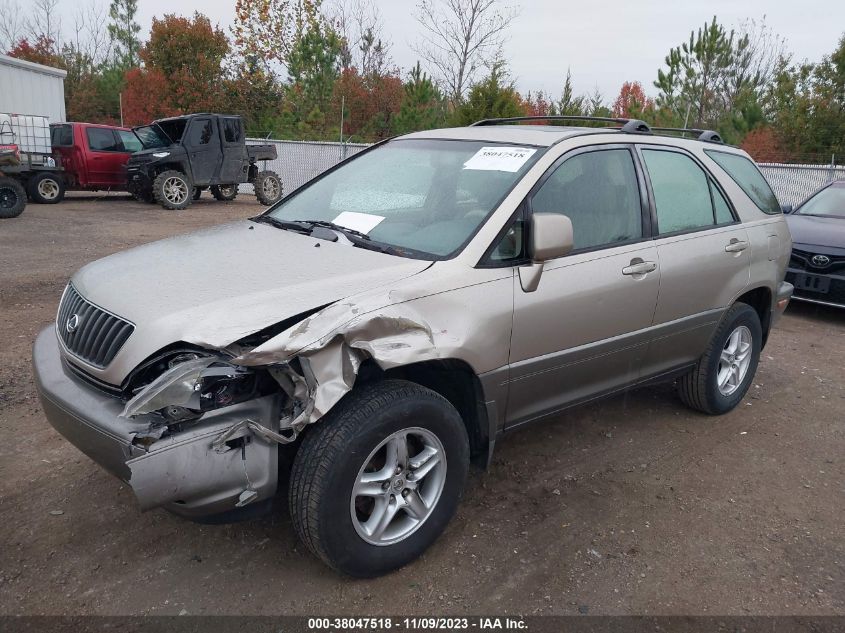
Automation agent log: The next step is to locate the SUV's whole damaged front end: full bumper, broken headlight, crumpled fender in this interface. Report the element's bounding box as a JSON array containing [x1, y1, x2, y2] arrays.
[[33, 276, 445, 518]]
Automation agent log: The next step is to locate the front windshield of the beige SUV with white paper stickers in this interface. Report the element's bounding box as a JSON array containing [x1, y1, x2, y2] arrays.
[[269, 139, 542, 259]]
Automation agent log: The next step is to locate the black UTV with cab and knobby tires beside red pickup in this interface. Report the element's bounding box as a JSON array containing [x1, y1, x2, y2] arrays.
[[126, 114, 282, 209]]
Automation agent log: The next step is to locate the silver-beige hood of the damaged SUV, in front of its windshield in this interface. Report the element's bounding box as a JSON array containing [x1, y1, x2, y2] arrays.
[[72, 220, 431, 359]]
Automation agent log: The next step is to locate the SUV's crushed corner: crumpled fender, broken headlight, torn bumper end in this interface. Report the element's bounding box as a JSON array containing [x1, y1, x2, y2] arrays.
[[113, 302, 436, 514]]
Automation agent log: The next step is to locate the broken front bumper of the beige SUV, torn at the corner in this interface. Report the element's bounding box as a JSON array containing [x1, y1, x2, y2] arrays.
[[33, 326, 283, 518]]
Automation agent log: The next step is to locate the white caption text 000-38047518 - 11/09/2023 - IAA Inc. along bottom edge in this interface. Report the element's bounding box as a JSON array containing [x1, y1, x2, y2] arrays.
[[308, 616, 528, 631]]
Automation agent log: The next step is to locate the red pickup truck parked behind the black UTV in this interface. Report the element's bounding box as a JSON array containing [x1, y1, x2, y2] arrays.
[[45, 123, 143, 203]]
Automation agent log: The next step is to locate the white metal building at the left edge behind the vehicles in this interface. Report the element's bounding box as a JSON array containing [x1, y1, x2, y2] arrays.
[[0, 55, 67, 123]]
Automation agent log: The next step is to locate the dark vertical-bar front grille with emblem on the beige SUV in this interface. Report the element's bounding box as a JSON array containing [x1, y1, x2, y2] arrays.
[[56, 285, 135, 368]]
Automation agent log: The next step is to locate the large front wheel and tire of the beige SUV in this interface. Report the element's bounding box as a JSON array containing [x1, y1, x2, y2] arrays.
[[289, 380, 469, 578]]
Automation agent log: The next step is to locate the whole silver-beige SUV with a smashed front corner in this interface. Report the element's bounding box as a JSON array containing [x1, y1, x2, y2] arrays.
[[33, 120, 792, 576]]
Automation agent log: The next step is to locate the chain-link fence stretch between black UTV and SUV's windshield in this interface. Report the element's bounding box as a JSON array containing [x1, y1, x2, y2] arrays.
[[241, 138, 369, 195]]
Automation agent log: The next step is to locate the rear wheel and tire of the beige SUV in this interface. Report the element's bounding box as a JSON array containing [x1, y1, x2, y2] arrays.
[[678, 303, 763, 415]]
